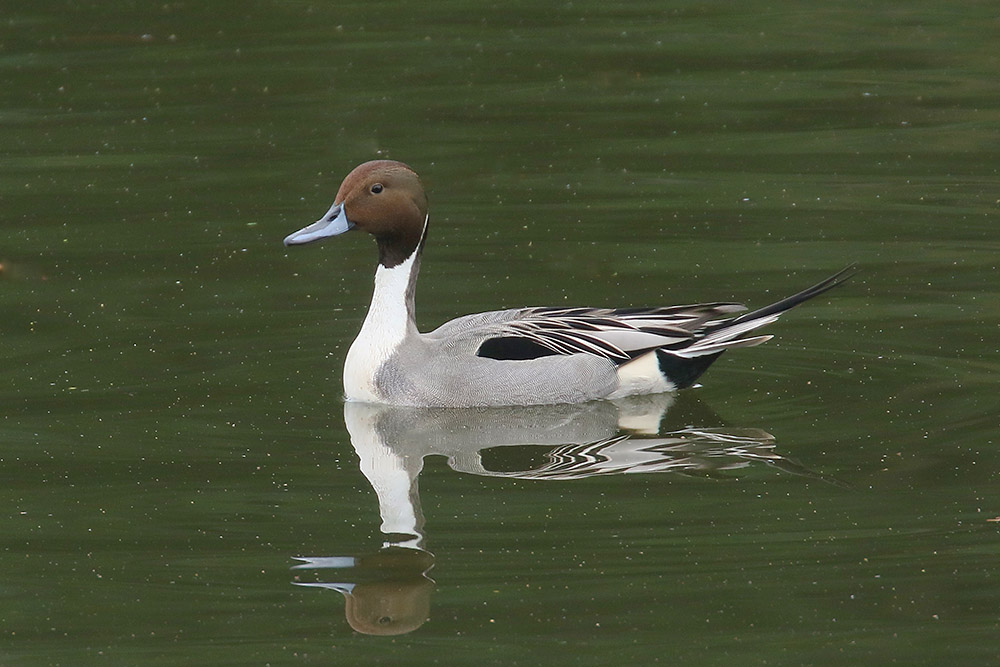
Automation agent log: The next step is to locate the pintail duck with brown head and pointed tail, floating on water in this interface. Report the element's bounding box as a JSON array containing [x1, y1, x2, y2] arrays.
[[284, 160, 855, 408]]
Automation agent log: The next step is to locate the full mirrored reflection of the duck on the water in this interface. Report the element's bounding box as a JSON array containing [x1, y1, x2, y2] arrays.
[[293, 394, 828, 635]]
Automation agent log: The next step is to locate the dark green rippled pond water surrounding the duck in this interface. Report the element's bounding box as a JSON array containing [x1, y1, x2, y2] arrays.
[[0, 2, 1000, 665]]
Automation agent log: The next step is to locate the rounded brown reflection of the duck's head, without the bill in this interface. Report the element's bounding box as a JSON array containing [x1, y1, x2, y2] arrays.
[[344, 575, 434, 635]]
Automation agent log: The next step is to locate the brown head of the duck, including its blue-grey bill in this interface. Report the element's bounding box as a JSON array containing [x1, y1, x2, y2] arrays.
[[285, 160, 427, 268]]
